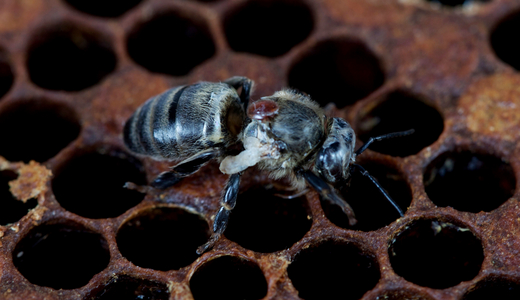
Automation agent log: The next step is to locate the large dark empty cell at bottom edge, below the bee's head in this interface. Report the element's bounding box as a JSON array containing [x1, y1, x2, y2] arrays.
[[288, 241, 380, 300]]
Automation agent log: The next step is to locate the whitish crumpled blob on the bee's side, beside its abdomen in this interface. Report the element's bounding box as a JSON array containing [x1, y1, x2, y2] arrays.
[[220, 137, 274, 174]]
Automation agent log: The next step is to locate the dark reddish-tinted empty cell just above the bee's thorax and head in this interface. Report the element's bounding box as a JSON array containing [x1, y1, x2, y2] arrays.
[[289, 39, 384, 108]]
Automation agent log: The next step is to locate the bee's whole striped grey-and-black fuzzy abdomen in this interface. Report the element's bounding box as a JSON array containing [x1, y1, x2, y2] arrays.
[[124, 82, 244, 160]]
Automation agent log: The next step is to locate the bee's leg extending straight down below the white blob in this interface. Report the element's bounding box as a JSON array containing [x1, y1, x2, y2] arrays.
[[197, 173, 242, 255]]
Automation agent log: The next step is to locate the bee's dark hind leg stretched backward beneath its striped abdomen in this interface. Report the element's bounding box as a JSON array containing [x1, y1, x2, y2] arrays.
[[151, 149, 220, 190]]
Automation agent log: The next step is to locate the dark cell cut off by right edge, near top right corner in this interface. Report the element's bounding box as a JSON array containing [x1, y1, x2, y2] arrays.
[[491, 11, 520, 70]]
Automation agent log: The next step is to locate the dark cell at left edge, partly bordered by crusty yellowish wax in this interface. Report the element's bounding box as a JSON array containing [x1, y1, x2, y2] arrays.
[[0, 171, 38, 225]]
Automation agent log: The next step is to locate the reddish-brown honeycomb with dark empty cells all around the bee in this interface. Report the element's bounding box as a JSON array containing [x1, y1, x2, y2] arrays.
[[0, 0, 520, 300]]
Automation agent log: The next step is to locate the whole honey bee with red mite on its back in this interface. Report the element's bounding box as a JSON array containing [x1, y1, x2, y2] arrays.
[[124, 76, 413, 254]]
